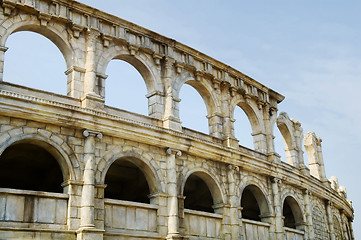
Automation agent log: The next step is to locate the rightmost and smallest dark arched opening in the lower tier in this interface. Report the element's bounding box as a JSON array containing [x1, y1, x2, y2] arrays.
[[282, 195, 305, 230]]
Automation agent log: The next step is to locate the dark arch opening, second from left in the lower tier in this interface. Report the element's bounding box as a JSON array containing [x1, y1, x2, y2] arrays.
[[104, 158, 151, 203]]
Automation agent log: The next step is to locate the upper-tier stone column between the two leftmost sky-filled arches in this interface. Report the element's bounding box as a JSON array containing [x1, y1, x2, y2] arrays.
[[82, 28, 104, 108]]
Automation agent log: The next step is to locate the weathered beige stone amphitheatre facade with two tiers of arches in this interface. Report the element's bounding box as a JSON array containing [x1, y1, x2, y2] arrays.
[[0, 0, 354, 240]]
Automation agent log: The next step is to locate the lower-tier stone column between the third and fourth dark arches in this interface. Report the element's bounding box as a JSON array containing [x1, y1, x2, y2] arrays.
[[228, 165, 243, 240]]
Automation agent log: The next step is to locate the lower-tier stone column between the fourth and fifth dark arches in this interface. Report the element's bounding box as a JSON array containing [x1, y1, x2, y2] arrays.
[[271, 178, 284, 240]]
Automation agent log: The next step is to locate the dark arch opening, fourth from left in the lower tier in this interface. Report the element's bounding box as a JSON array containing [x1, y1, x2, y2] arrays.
[[241, 185, 269, 222]]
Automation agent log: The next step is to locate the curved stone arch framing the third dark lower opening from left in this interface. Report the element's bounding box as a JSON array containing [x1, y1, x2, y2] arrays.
[[179, 168, 225, 209]]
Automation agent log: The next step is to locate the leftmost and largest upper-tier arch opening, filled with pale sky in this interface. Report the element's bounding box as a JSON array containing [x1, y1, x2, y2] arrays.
[[3, 30, 68, 95]]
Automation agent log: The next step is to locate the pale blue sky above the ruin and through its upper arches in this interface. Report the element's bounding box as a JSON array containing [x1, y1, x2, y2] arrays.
[[4, 0, 361, 236]]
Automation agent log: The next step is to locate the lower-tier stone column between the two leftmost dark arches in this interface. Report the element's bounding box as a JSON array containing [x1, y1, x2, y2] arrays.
[[78, 130, 102, 240]]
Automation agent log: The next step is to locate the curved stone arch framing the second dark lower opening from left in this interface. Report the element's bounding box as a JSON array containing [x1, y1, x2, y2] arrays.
[[96, 150, 163, 194]]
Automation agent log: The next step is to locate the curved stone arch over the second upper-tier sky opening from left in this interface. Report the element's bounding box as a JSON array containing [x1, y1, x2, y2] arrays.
[[98, 45, 163, 94]]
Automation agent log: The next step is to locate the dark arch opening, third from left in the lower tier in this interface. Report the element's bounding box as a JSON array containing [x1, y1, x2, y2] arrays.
[[183, 174, 214, 213]]
